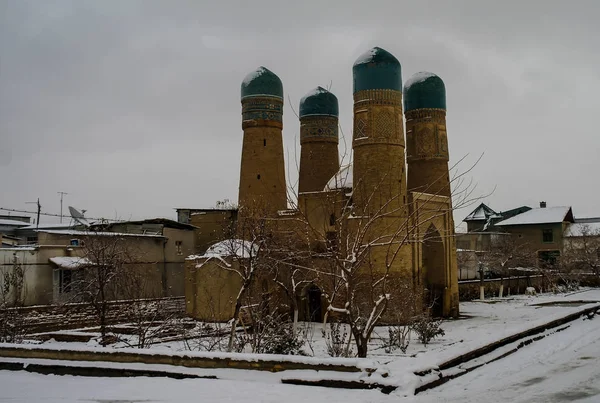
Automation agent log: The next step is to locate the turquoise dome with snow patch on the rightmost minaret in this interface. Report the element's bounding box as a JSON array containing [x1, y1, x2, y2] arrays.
[[404, 71, 446, 112]]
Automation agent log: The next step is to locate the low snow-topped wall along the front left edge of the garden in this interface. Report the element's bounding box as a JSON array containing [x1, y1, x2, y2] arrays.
[[0, 344, 366, 372]]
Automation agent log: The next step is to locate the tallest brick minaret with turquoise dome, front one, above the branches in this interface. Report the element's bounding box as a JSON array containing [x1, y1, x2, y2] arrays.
[[352, 47, 406, 216]]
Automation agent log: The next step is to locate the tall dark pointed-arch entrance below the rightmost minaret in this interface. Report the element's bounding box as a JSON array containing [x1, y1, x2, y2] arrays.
[[423, 224, 446, 316]]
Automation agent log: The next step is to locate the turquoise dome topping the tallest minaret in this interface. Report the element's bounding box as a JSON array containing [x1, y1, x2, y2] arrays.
[[352, 47, 402, 93]]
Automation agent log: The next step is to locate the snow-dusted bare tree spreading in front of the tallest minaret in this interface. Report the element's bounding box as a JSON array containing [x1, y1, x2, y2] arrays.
[[278, 159, 474, 357]]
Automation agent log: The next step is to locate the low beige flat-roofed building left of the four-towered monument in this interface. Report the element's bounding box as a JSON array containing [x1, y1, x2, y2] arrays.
[[0, 218, 195, 305]]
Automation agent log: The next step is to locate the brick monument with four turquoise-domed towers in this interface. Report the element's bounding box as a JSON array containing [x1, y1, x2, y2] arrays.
[[186, 47, 458, 322]]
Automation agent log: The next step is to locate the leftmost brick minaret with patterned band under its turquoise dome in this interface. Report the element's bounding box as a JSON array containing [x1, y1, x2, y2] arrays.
[[238, 67, 287, 216]]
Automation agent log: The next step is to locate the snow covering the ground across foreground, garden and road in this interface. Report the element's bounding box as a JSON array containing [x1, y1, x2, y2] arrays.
[[0, 289, 600, 403]]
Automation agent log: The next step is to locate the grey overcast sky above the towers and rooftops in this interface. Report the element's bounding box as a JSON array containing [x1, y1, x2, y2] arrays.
[[0, 0, 600, 226]]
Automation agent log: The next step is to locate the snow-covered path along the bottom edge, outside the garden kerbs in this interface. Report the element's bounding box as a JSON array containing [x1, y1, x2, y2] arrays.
[[0, 317, 600, 403]]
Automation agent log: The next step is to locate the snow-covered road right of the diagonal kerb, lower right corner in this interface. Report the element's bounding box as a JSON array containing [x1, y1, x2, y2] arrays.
[[416, 316, 600, 403]]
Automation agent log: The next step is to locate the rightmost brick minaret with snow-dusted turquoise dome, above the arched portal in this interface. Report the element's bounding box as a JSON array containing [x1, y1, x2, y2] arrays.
[[404, 72, 450, 200]]
